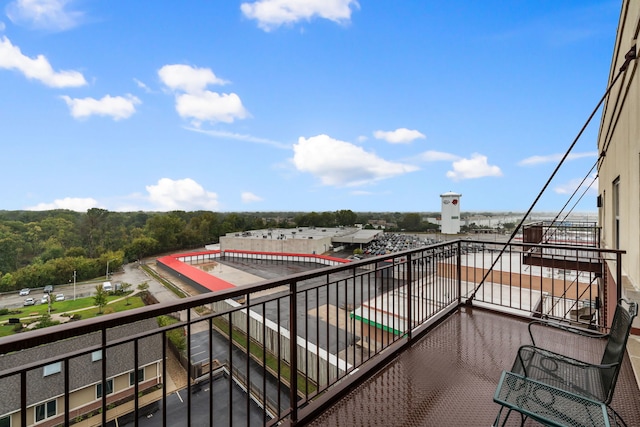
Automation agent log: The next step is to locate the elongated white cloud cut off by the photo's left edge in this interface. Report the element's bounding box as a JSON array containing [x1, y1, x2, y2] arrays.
[[0, 36, 87, 88]]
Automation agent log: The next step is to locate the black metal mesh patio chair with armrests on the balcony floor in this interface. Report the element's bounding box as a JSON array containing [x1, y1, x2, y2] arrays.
[[511, 299, 638, 416]]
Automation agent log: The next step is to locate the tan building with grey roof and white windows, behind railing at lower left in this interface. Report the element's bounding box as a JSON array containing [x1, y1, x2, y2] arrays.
[[0, 319, 163, 426]]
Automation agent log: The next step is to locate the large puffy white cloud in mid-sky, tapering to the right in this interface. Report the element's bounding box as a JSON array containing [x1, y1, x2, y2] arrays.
[[292, 135, 418, 187]]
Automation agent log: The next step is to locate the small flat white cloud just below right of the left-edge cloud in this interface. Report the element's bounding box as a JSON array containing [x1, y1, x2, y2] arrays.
[[61, 94, 140, 120]]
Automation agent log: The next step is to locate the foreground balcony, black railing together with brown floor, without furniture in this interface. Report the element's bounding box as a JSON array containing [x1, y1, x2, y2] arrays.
[[0, 240, 640, 427]]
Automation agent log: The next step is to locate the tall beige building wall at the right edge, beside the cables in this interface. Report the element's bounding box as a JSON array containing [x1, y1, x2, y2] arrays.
[[598, 0, 640, 296]]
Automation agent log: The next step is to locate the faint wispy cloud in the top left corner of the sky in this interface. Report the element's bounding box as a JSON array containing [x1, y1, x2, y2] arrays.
[[6, 0, 84, 31]]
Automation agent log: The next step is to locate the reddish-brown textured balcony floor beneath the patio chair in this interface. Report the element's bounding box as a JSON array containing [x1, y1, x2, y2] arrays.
[[310, 307, 640, 426]]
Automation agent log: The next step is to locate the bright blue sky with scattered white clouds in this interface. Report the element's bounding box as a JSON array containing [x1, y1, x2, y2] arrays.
[[0, 0, 620, 212]]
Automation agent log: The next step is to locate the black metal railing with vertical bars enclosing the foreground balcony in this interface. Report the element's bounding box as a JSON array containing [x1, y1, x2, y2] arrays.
[[0, 240, 621, 426]]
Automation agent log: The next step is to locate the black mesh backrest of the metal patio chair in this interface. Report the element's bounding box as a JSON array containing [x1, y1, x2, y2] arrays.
[[601, 299, 638, 403]]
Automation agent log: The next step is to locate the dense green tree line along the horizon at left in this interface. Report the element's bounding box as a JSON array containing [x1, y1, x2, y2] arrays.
[[0, 208, 440, 292]]
